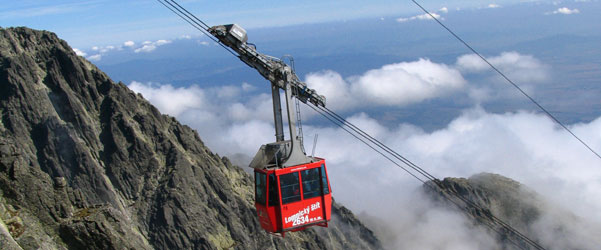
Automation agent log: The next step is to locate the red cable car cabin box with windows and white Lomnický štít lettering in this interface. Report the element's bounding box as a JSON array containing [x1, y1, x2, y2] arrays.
[[255, 158, 332, 236]]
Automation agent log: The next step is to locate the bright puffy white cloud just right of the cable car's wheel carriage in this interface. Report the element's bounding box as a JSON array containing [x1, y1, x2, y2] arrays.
[[306, 59, 466, 110]]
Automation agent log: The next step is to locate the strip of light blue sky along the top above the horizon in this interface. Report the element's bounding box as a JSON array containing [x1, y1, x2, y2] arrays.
[[0, 0, 556, 47]]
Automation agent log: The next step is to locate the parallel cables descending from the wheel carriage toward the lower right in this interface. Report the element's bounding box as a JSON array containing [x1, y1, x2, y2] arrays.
[[309, 105, 545, 249]]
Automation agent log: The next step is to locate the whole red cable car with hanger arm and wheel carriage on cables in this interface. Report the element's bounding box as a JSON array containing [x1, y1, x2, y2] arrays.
[[208, 24, 332, 236]]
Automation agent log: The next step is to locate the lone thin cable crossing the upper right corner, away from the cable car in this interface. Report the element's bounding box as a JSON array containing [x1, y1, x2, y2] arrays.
[[411, 0, 601, 159]]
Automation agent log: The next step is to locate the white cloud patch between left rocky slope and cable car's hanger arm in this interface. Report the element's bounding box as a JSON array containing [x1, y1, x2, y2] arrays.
[[128, 81, 274, 156]]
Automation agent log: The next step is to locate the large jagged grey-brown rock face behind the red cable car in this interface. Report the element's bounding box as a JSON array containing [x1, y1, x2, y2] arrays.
[[0, 28, 380, 249]]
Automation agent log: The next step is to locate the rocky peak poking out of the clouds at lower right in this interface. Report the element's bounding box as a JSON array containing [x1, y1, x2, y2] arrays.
[[423, 173, 601, 250]]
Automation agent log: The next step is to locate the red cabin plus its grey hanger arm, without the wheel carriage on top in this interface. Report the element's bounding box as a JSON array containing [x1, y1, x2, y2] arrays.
[[250, 77, 332, 237]]
